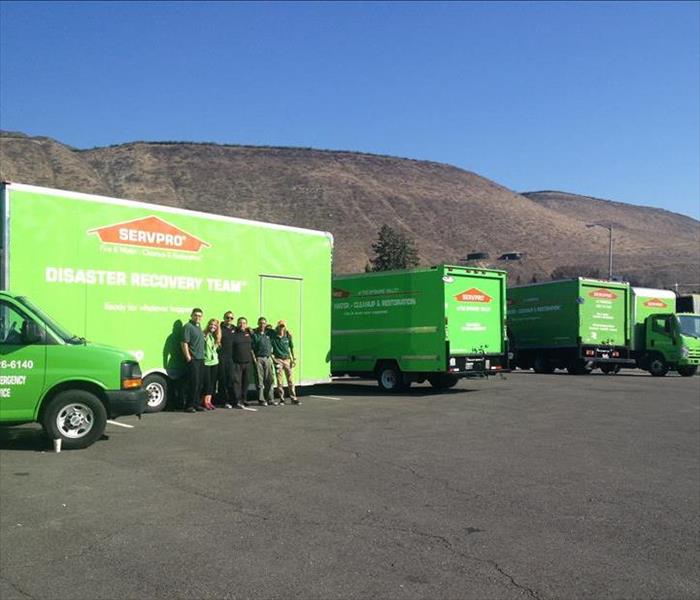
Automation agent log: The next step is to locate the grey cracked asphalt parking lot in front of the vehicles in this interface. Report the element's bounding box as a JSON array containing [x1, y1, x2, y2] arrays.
[[0, 373, 700, 600]]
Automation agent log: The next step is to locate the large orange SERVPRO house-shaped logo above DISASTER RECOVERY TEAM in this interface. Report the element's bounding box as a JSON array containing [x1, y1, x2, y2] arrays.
[[88, 216, 209, 252]]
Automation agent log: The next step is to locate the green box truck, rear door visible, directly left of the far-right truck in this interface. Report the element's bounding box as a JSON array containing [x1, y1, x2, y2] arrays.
[[508, 277, 634, 374]]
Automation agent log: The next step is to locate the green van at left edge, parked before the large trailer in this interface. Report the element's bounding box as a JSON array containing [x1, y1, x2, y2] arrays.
[[0, 291, 147, 449]]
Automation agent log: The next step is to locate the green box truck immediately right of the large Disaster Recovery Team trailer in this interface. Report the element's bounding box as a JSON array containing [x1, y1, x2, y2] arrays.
[[331, 265, 507, 391]]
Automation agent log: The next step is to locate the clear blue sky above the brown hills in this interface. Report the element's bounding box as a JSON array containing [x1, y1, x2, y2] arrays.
[[0, 1, 700, 218]]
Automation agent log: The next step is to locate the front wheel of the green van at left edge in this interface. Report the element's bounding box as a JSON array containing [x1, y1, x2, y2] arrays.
[[41, 390, 107, 450]]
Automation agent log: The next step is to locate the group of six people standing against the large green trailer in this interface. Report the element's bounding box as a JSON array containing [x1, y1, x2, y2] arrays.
[[181, 308, 301, 413]]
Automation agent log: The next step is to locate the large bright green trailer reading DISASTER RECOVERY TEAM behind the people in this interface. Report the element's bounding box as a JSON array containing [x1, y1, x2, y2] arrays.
[[0, 183, 333, 412]]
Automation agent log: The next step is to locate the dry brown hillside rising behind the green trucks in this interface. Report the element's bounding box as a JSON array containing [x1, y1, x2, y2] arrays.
[[0, 132, 700, 285]]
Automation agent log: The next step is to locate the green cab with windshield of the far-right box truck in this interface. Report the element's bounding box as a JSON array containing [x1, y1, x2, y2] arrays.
[[637, 314, 700, 377]]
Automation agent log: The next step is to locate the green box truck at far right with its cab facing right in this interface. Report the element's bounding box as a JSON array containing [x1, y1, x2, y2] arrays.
[[632, 287, 700, 377]]
